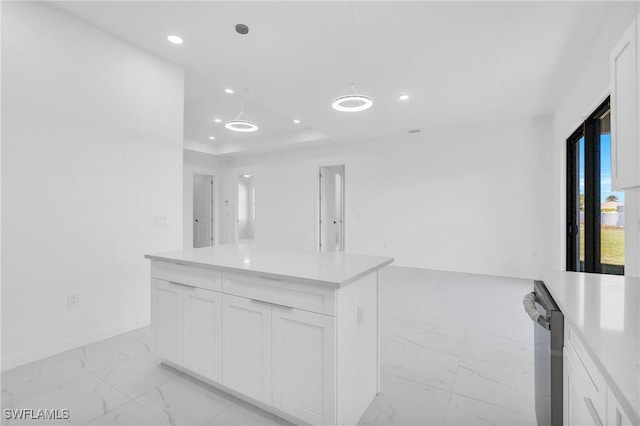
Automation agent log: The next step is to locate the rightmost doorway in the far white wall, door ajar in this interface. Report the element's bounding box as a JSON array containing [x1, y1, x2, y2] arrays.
[[318, 165, 344, 251]]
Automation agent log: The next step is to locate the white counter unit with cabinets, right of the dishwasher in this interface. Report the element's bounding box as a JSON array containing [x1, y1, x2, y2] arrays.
[[541, 270, 640, 426]]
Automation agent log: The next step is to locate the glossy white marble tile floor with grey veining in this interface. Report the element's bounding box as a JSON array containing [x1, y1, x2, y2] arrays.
[[1, 267, 536, 426]]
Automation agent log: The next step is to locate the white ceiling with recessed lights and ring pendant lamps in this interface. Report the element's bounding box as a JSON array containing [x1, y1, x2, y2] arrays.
[[53, 1, 616, 155]]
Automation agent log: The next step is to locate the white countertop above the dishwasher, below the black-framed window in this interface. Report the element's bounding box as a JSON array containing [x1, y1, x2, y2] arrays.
[[542, 271, 640, 424]]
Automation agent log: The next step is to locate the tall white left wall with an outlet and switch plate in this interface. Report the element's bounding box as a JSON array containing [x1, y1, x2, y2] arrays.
[[2, 2, 184, 369]]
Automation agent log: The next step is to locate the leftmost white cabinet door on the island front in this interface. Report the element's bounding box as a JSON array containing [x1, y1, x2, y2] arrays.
[[151, 279, 183, 364]]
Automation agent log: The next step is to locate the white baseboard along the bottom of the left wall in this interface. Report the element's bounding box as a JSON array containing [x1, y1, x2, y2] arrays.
[[1, 318, 151, 371]]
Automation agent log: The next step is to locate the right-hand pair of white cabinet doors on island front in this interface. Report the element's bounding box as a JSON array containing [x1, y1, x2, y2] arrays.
[[222, 294, 336, 424]]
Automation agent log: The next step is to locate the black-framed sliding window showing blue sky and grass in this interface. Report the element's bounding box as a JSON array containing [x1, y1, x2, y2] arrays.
[[567, 99, 624, 275]]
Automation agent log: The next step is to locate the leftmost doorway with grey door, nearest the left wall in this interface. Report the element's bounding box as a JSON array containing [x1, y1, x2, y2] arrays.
[[193, 173, 214, 248]]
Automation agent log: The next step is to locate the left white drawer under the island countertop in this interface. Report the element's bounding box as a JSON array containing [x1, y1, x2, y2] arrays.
[[151, 260, 222, 291]]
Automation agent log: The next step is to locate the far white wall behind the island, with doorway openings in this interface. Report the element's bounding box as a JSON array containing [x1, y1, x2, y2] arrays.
[[219, 118, 551, 277]]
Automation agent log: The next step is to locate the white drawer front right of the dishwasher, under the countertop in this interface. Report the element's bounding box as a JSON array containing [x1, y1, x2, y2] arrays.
[[564, 327, 607, 422]]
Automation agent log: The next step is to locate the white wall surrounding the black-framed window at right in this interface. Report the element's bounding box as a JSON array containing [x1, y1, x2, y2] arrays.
[[548, 2, 640, 276]]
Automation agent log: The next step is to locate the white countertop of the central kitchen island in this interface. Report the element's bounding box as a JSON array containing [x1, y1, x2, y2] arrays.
[[145, 244, 393, 287]]
